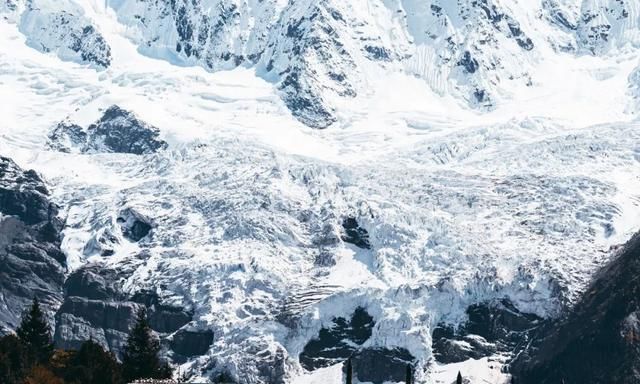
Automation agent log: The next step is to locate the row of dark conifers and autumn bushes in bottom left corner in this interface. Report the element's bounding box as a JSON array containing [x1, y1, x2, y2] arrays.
[[0, 299, 173, 384]]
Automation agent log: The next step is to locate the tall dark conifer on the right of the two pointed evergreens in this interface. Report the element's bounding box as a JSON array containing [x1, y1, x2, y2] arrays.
[[122, 309, 172, 382]]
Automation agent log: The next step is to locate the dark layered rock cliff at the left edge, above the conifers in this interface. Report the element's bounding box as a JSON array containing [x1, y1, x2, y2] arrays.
[[0, 156, 66, 331]]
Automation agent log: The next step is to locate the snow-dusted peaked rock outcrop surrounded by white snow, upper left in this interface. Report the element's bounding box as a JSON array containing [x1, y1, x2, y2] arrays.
[[49, 105, 167, 155]]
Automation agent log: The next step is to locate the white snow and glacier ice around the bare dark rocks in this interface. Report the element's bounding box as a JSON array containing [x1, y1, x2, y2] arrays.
[[0, 0, 640, 383]]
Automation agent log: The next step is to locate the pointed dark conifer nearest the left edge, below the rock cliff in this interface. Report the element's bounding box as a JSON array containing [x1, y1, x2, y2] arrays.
[[16, 298, 53, 364]]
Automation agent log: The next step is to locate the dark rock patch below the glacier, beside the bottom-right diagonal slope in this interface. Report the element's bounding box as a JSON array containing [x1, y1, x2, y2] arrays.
[[432, 299, 543, 364]]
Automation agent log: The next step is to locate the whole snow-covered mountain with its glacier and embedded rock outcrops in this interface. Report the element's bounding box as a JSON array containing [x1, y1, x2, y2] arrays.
[[0, 0, 640, 384]]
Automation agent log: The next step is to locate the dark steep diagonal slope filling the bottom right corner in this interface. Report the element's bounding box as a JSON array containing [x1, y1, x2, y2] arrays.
[[512, 235, 640, 384]]
